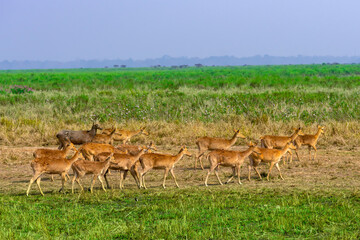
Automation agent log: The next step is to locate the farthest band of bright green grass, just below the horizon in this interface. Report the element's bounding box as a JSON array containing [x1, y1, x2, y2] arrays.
[[0, 65, 360, 91]]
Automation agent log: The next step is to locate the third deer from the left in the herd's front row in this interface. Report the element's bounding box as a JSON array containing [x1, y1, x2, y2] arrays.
[[104, 149, 148, 189]]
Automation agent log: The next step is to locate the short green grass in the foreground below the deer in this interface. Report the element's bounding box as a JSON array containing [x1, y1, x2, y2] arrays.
[[0, 187, 360, 239]]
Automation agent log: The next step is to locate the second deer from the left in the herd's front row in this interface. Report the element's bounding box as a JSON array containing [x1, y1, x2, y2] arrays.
[[71, 154, 113, 193]]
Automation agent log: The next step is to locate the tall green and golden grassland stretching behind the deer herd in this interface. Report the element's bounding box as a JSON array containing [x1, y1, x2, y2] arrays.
[[0, 65, 360, 146]]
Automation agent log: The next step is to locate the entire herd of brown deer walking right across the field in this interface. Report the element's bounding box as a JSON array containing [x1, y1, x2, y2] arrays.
[[26, 124, 324, 195]]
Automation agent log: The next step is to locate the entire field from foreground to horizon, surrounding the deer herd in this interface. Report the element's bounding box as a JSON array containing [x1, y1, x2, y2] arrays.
[[0, 65, 360, 239]]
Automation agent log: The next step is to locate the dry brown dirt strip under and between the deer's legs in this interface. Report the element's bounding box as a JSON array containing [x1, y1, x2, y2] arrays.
[[0, 146, 360, 195]]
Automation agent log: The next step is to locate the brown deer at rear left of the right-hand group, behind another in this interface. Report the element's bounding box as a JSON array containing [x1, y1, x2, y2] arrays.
[[195, 130, 245, 169]]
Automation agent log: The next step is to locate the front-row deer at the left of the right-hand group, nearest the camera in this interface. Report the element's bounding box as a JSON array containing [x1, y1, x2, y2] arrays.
[[205, 142, 256, 186]]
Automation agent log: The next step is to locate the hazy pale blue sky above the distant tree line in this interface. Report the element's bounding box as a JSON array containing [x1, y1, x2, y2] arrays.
[[0, 0, 360, 61]]
